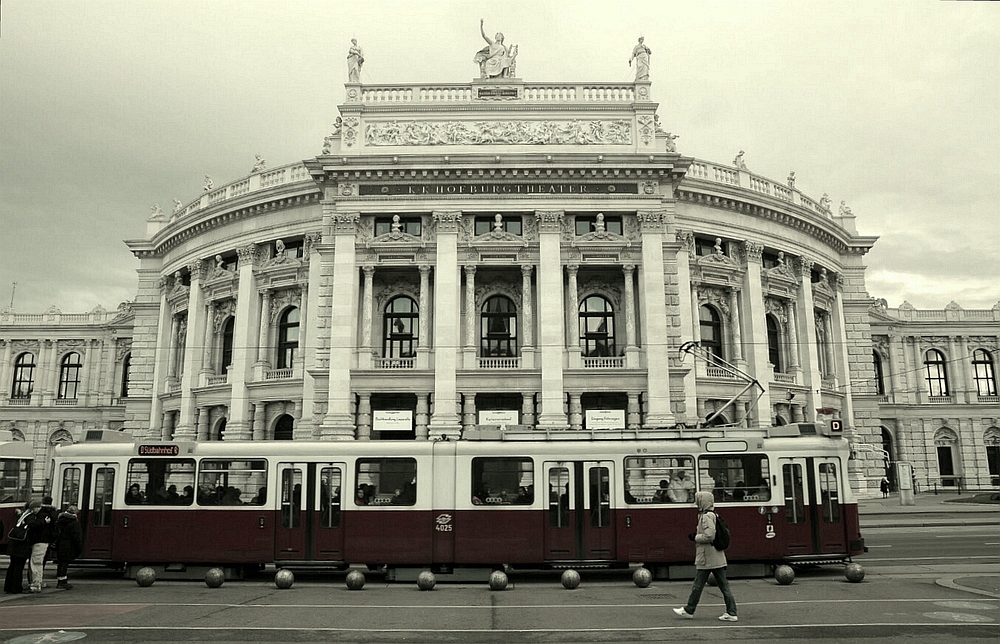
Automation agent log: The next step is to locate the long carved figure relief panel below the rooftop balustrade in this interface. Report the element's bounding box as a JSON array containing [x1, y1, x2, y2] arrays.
[[368, 119, 632, 146]]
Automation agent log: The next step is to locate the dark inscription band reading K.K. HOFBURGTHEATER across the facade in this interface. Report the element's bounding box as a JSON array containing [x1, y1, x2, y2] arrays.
[[358, 181, 639, 197]]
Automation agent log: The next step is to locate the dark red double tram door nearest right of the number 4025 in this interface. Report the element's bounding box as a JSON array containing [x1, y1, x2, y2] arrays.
[[544, 461, 615, 560]]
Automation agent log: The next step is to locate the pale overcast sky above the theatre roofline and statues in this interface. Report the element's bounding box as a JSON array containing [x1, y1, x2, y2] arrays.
[[0, 0, 1000, 312]]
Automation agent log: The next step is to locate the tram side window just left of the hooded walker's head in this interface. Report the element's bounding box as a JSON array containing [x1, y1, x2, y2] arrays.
[[625, 456, 695, 504]]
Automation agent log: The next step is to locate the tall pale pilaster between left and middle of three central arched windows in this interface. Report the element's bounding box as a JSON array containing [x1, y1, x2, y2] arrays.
[[428, 211, 462, 438]]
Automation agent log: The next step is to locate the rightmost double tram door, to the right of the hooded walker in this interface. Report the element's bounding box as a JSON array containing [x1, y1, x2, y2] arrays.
[[779, 458, 847, 555]]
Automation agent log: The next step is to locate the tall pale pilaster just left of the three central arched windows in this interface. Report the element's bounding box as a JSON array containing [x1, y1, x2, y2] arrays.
[[320, 211, 361, 440]]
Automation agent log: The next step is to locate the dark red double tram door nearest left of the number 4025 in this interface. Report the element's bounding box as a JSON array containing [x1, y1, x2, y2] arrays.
[[274, 463, 345, 561]]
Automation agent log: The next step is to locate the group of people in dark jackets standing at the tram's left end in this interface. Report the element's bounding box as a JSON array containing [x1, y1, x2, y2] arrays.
[[3, 496, 83, 595]]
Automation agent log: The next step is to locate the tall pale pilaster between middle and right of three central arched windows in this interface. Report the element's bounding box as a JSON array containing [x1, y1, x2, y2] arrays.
[[535, 210, 568, 429]]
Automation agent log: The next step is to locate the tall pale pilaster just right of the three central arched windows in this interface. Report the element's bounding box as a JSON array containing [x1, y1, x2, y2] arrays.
[[637, 210, 675, 429]]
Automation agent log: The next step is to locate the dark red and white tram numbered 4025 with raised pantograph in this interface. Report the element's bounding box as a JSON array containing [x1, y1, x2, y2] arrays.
[[47, 424, 864, 576]]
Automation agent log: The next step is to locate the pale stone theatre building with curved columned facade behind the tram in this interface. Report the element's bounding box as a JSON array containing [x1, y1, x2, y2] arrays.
[[0, 65, 1000, 494]]
